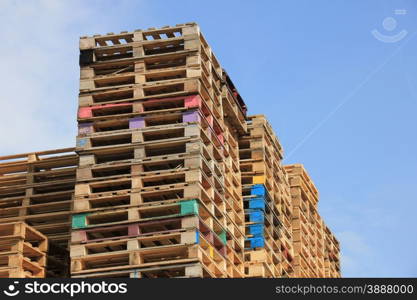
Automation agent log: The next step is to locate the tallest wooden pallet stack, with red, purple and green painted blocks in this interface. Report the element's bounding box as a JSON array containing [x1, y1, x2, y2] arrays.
[[71, 23, 246, 278]]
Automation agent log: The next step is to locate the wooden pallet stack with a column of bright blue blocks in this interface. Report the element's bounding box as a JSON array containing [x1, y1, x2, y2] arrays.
[[239, 115, 293, 277]]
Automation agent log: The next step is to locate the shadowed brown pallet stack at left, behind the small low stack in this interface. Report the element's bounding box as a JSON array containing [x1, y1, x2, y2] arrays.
[[0, 148, 78, 277]]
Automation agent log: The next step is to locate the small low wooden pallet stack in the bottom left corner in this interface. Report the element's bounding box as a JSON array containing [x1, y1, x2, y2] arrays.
[[0, 222, 48, 278]]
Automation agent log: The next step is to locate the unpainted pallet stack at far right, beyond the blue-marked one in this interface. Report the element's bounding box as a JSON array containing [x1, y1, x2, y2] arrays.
[[285, 164, 340, 277]]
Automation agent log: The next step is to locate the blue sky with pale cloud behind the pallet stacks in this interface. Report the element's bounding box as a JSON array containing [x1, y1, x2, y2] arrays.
[[0, 0, 417, 277]]
